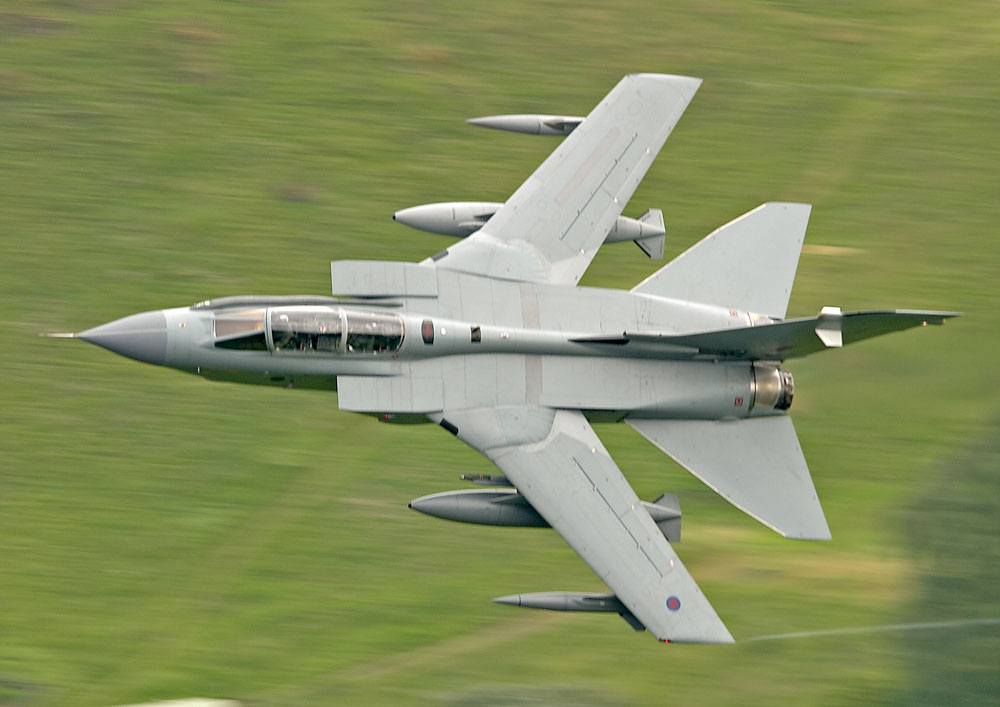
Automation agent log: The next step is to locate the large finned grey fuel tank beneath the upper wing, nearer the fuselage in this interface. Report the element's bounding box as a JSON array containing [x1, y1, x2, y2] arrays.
[[392, 201, 667, 259]]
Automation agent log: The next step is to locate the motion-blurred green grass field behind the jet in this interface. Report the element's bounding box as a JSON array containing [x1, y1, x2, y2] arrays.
[[0, 0, 1000, 706]]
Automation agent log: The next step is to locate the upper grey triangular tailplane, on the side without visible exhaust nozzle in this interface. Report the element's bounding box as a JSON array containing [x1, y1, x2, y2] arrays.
[[632, 202, 812, 319]]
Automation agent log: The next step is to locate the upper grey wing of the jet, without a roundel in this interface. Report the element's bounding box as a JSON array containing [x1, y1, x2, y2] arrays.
[[428, 74, 701, 285]]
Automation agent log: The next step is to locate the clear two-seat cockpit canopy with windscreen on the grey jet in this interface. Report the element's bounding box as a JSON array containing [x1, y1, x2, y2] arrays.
[[215, 306, 403, 355]]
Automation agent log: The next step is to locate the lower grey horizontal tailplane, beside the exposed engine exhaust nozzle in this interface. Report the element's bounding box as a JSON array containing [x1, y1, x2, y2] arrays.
[[626, 417, 830, 540]]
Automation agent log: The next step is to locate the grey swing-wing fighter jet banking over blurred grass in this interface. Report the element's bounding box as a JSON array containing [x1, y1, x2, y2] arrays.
[[66, 74, 957, 643]]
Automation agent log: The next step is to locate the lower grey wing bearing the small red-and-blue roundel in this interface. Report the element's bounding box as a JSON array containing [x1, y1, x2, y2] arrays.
[[442, 410, 733, 643]]
